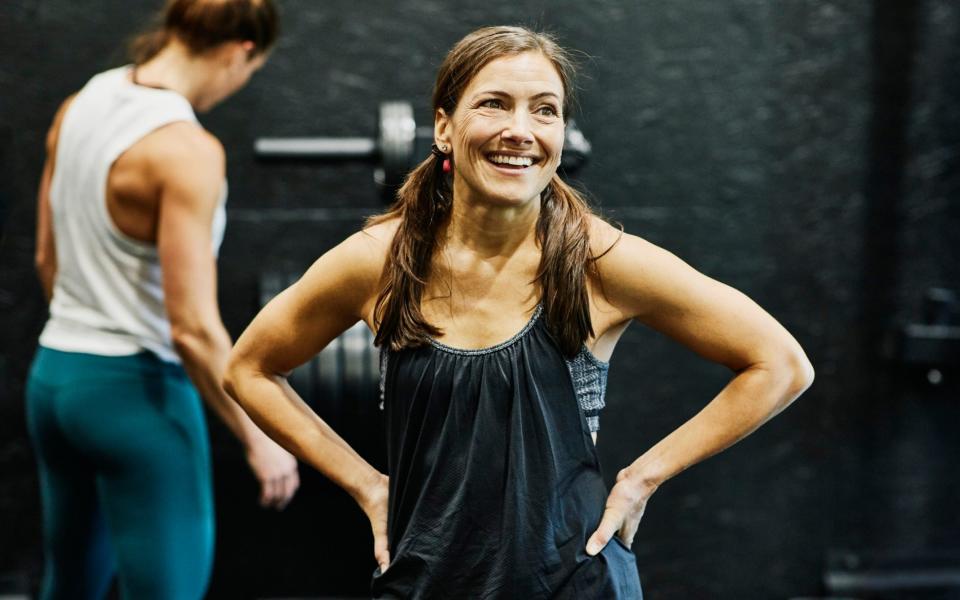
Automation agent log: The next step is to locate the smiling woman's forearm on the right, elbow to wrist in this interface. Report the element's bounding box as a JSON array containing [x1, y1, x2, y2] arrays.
[[623, 358, 813, 486]]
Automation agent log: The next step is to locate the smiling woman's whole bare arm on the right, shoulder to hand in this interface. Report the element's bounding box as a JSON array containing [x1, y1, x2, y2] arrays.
[[594, 219, 813, 547]]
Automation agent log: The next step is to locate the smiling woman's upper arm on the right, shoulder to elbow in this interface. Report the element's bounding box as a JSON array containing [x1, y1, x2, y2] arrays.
[[597, 223, 806, 371]]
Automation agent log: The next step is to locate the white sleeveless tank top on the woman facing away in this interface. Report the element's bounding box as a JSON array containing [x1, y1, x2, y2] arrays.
[[40, 66, 226, 363]]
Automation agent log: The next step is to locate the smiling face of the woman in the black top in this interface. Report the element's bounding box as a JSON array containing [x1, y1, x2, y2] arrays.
[[435, 52, 564, 211]]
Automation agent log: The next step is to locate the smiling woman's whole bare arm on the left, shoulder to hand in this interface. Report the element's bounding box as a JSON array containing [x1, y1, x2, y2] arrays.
[[224, 226, 389, 569]]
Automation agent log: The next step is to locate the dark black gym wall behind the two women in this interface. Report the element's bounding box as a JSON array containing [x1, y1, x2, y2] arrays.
[[0, 0, 960, 599]]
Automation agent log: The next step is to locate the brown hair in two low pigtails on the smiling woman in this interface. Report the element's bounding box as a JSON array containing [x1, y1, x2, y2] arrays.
[[367, 27, 616, 357]]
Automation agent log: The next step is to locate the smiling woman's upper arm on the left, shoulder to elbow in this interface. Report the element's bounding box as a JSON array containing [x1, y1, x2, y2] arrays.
[[231, 226, 389, 374]]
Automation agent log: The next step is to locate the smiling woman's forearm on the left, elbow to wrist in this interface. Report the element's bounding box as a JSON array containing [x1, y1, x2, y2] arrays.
[[224, 364, 383, 507]]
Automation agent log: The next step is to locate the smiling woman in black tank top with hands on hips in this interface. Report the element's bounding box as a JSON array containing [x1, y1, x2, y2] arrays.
[[226, 27, 812, 600]]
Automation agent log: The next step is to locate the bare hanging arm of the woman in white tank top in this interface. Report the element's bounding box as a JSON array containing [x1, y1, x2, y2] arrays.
[[152, 123, 299, 508]]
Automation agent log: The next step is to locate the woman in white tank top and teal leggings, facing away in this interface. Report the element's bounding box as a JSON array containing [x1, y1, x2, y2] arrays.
[[27, 0, 298, 600]]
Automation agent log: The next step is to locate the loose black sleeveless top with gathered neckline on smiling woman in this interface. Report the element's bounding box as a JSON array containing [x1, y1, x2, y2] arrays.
[[372, 306, 642, 600]]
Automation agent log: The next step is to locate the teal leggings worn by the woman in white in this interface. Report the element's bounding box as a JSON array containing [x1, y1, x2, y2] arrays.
[[27, 348, 214, 600]]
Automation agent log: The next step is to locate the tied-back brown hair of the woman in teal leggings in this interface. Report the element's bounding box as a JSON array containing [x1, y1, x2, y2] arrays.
[[128, 0, 279, 64]]
